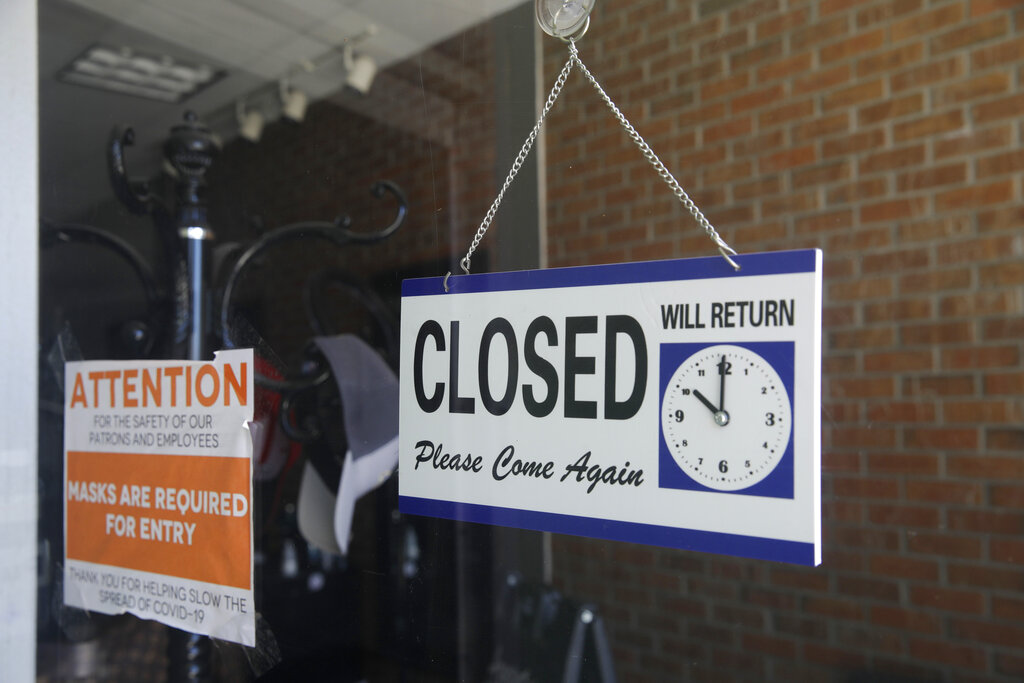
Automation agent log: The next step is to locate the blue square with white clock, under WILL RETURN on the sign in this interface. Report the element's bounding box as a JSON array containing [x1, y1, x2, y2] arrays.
[[658, 342, 794, 499]]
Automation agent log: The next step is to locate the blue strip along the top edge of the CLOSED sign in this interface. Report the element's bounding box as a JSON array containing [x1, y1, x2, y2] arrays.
[[401, 249, 818, 297]]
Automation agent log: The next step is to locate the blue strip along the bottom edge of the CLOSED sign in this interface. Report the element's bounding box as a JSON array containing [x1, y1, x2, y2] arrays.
[[398, 496, 815, 566]]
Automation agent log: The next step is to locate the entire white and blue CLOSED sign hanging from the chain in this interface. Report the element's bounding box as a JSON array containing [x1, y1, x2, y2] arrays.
[[399, 250, 821, 565]]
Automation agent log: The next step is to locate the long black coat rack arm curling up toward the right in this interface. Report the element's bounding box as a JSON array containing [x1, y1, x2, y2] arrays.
[[220, 180, 409, 348]]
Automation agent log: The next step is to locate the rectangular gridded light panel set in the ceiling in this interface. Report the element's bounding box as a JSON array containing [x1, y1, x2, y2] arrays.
[[57, 45, 224, 103]]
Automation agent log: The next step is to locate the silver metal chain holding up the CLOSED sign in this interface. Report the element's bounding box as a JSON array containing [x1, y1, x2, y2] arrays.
[[444, 39, 739, 292]]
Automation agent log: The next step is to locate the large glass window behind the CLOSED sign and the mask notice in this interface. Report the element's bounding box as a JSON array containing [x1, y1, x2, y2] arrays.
[[28, 0, 1024, 681]]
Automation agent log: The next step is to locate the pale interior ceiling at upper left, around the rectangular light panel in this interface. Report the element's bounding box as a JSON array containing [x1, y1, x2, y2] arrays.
[[39, 0, 523, 220]]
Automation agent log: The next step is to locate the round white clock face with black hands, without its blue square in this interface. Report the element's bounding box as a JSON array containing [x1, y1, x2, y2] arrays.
[[660, 344, 793, 492]]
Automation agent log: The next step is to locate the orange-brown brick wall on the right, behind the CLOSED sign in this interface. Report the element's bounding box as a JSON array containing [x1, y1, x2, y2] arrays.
[[544, 0, 1024, 681]]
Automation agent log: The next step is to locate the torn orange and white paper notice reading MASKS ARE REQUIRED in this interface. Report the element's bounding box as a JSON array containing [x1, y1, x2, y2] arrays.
[[63, 349, 256, 645]]
